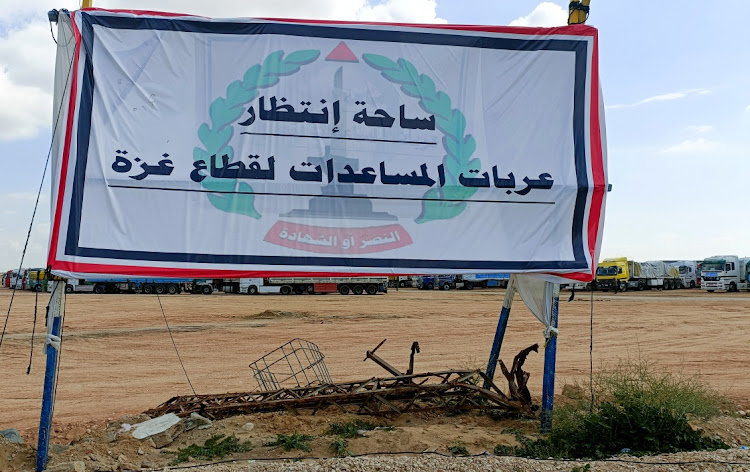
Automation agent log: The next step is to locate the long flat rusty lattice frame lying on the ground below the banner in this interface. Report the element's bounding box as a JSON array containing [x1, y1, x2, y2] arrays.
[[145, 370, 531, 420]]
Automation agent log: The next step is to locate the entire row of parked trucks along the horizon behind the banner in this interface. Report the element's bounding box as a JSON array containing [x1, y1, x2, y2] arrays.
[[2, 255, 750, 295]]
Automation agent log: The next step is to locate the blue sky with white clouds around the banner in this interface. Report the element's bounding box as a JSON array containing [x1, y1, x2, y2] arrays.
[[0, 0, 750, 270]]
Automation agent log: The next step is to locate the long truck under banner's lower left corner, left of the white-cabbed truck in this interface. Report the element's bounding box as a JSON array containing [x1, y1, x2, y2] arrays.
[[65, 278, 214, 295]]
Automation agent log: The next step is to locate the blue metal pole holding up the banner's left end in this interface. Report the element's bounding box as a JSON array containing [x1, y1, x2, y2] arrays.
[[36, 281, 65, 472]]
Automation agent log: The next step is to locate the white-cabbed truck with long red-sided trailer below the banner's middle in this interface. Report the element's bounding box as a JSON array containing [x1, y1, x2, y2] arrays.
[[229, 277, 388, 295]]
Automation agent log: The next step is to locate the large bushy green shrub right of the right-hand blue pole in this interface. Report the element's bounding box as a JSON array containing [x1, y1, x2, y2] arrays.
[[495, 359, 728, 459]]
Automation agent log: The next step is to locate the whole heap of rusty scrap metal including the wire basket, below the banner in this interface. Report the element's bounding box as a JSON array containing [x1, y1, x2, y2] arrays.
[[145, 339, 538, 420]]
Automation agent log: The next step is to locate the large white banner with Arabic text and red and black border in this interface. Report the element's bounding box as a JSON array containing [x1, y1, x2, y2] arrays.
[[49, 9, 607, 280]]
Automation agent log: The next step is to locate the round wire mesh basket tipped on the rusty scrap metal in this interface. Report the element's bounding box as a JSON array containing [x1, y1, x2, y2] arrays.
[[250, 338, 331, 391]]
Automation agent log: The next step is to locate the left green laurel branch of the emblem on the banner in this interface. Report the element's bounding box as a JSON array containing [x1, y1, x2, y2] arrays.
[[193, 49, 320, 218]]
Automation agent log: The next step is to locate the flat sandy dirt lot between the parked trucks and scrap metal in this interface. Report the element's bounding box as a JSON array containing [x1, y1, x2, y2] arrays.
[[0, 289, 750, 439]]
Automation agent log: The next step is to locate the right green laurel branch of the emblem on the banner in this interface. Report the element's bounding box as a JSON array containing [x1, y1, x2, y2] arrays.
[[362, 54, 480, 223]]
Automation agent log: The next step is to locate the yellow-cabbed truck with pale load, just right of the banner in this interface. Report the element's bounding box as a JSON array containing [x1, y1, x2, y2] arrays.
[[596, 257, 683, 292]]
